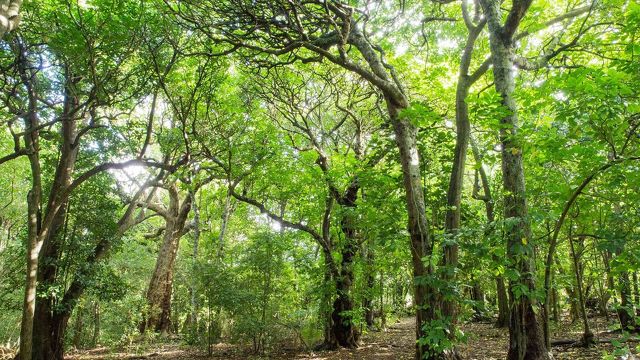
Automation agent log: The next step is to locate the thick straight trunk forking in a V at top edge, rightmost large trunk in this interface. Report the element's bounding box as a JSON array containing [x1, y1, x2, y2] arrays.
[[481, 0, 550, 360]]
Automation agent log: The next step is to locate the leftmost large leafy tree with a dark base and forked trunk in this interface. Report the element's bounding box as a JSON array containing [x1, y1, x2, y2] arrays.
[[2, 4, 182, 359]]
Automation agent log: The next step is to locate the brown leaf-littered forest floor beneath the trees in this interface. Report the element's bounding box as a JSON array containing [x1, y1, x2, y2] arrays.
[[60, 318, 636, 360]]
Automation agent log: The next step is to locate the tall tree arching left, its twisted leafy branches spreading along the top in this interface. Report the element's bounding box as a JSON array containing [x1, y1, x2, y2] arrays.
[[170, 0, 437, 359]]
